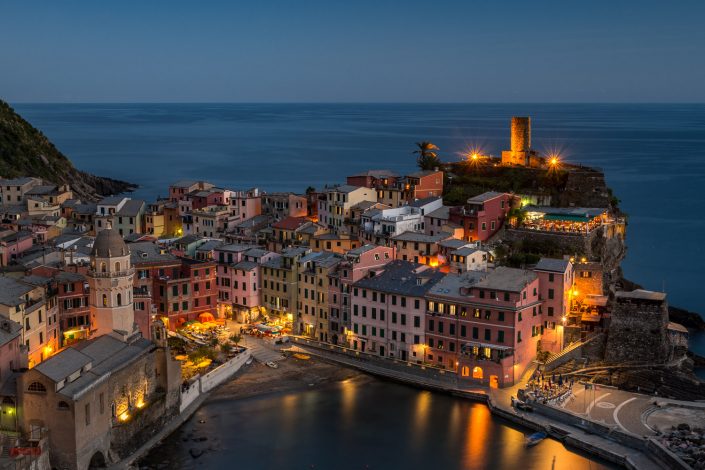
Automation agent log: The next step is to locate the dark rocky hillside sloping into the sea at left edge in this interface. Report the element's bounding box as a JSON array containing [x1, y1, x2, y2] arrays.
[[0, 100, 135, 200]]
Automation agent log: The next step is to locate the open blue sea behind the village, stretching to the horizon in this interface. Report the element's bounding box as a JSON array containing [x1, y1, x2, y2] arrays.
[[16, 104, 705, 354]]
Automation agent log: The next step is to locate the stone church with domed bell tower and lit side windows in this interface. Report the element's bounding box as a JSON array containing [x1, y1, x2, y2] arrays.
[[18, 229, 181, 470]]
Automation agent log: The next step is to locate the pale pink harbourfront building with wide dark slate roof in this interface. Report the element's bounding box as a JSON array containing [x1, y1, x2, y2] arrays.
[[348, 261, 443, 363]]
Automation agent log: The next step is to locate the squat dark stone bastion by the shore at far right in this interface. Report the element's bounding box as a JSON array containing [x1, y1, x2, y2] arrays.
[[605, 289, 670, 364]]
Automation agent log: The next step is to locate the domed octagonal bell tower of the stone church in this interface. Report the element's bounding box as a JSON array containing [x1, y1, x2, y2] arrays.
[[88, 228, 138, 341]]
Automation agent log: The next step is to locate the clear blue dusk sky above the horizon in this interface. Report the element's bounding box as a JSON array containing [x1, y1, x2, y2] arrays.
[[0, 0, 705, 102]]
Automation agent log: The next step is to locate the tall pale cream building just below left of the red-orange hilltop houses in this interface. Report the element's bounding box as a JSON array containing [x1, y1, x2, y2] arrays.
[[318, 185, 377, 232]]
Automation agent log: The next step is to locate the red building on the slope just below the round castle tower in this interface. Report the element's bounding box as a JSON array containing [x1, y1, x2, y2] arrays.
[[449, 191, 513, 242]]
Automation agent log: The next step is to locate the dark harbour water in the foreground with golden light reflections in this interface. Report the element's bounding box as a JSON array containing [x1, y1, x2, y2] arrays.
[[140, 378, 608, 470]]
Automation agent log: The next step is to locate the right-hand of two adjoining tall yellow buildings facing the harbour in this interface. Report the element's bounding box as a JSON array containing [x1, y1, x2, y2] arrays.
[[296, 251, 343, 342]]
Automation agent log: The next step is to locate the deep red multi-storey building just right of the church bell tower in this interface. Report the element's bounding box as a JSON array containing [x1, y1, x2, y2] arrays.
[[153, 258, 218, 330]]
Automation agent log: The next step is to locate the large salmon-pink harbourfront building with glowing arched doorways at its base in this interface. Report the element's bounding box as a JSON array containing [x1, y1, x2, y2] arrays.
[[425, 267, 543, 387]]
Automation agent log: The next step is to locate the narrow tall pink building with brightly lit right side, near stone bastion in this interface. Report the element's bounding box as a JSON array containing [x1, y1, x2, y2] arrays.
[[534, 258, 574, 352]]
